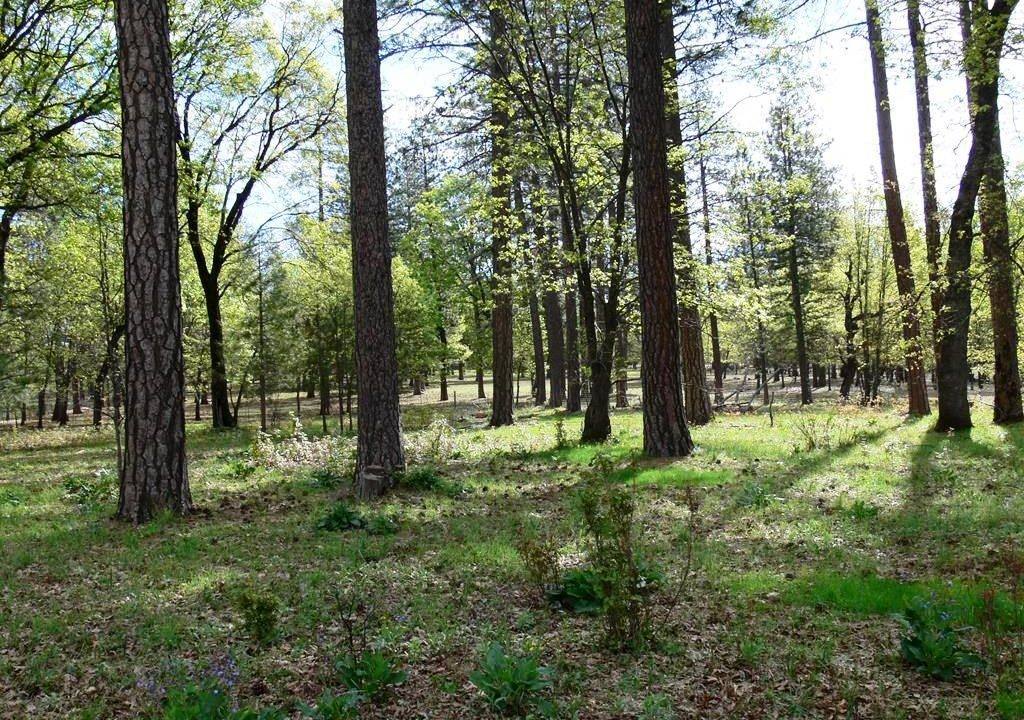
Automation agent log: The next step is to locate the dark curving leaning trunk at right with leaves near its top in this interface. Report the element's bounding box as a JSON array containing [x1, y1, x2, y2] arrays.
[[936, 0, 1017, 430]]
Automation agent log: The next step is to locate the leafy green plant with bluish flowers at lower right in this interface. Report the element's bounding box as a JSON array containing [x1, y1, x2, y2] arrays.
[[900, 599, 984, 680]]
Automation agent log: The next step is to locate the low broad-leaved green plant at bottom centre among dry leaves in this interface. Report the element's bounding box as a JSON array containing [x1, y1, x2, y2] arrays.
[[469, 642, 552, 716]]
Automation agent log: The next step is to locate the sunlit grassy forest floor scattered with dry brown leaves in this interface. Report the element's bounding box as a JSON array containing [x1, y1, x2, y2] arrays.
[[0, 406, 1024, 720]]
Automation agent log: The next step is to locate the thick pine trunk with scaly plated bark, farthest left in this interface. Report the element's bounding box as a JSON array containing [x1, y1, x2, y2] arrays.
[[116, 0, 193, 523]]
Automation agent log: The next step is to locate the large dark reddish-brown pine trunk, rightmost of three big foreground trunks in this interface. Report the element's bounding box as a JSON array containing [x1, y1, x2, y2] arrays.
[[626, 0, 693, 457]]
